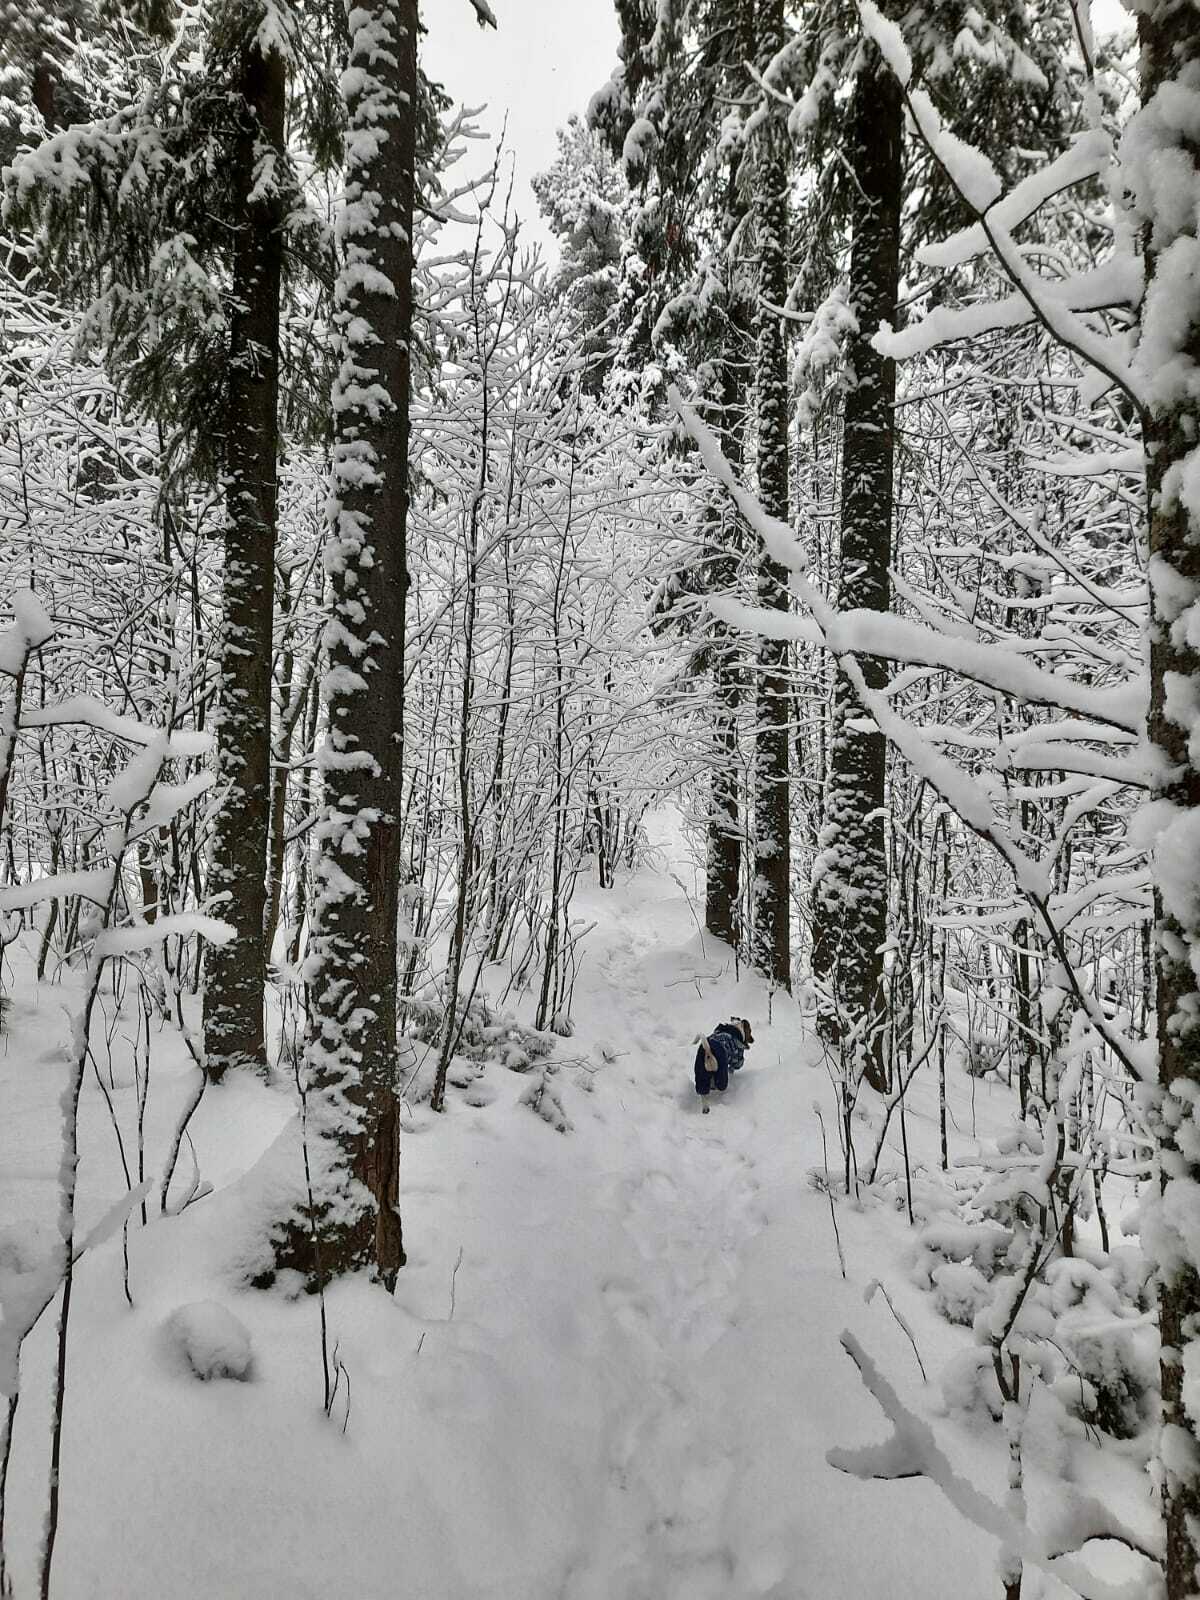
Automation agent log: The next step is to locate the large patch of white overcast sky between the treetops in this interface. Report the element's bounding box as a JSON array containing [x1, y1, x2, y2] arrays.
[[421, 0, 618, 256]]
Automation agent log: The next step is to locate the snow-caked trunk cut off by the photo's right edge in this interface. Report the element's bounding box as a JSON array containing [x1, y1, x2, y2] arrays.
[[1131, 9, 1200, 1600]]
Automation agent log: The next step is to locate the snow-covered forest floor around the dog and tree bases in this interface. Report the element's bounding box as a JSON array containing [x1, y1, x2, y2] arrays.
[[0, 819, 1126, 1600]]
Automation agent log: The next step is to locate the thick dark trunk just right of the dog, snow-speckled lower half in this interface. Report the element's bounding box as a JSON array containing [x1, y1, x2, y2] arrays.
[[813, 45, 904, 1091]]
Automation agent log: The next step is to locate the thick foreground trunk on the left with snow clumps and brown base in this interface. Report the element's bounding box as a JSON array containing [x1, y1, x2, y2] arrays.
[[292, 0, 419, 1288]]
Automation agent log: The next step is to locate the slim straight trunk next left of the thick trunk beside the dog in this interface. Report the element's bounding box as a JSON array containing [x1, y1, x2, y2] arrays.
[[754, 0, 792, 989]]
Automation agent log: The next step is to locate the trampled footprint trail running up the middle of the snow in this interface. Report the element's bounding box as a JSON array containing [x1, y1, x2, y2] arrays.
[[565, 921, 755, 1600]]
